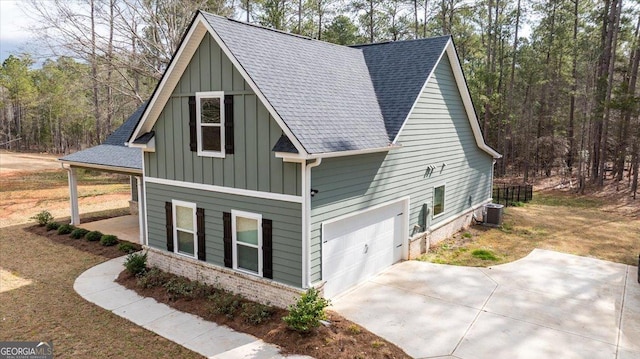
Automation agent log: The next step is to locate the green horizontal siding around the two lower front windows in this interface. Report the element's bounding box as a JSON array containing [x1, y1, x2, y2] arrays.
[[146, 182, 302, 287]]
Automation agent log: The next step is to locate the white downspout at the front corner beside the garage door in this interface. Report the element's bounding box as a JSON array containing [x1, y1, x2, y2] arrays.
[[302, 158, 322, 289]]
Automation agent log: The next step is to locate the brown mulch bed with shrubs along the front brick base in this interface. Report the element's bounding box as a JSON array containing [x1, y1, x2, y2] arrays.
[[117, 271, 409, 358]]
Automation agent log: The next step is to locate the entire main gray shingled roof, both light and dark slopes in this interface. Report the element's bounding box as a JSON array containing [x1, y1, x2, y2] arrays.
[[202, 12, 449, 153]]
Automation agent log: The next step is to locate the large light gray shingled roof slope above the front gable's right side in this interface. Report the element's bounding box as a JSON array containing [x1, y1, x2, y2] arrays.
[[203, 13, 389, 153]]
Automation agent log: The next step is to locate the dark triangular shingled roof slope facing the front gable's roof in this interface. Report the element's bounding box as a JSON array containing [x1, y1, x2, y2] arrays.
[[354, 36, 450, 140]]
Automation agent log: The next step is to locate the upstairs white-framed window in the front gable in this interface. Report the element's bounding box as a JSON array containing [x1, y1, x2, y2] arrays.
[[196, 91, 225, 157]]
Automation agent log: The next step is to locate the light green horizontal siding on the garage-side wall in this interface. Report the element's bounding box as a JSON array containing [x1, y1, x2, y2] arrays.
[[311, 56, 493, 282]]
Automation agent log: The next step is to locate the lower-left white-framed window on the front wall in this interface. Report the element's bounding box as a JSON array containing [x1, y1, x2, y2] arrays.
[[171, 200, 198, 258]]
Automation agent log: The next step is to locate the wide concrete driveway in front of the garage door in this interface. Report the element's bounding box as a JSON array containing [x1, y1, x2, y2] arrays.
[[332, 249, 640, 359]]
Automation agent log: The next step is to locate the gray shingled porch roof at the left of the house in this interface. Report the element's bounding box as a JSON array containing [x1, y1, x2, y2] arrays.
[[60, 102, 147, 171]]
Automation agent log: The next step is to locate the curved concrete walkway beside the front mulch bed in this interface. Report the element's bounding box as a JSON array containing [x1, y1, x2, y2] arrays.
[[73, 257, 305, 359]]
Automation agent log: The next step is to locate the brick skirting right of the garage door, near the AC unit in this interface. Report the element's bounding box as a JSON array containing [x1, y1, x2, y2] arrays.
[[409, 204, 484, 259]]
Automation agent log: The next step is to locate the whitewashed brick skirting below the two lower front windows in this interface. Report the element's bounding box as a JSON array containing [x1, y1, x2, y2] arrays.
[[145, 246, 304, 308]]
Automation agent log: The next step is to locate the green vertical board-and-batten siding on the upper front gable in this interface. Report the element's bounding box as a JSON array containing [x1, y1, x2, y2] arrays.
[[145, 35, 301, 196]]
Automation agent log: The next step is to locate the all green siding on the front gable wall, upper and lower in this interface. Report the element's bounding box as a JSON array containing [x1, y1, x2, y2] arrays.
[[145, 35, 302, 287]]
